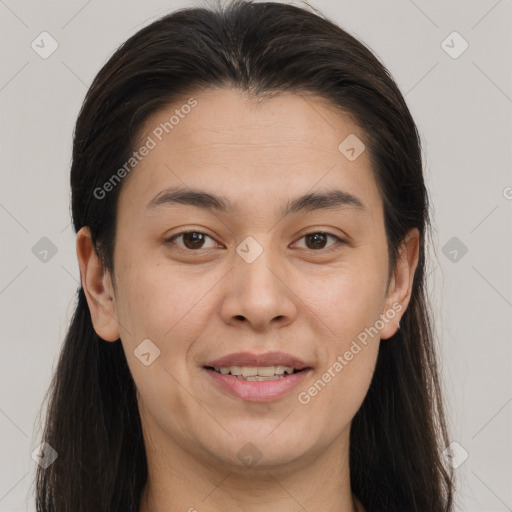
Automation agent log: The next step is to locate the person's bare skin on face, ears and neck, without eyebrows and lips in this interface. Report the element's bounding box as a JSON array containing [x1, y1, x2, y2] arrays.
[[76, 89, 419, 512]]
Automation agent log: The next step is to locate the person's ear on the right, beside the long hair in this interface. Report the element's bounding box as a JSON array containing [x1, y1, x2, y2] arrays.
[[380, 228, 420, 340]]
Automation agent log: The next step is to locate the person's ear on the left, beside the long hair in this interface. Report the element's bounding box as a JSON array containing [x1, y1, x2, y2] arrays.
[[76, 226, 120, 341]]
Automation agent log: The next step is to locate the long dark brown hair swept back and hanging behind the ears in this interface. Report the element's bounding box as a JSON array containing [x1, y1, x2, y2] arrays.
[[36, 0, 454, 512]]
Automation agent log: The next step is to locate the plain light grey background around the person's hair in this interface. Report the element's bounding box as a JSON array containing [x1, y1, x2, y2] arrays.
[[0, 0, 512, 512]]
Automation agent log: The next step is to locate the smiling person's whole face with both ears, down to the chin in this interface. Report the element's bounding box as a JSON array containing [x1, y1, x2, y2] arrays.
[[77, 89, 417, 476]]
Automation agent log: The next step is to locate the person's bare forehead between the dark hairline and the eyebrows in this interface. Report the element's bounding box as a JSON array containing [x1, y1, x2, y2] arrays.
[[119, 89, 381, 218]]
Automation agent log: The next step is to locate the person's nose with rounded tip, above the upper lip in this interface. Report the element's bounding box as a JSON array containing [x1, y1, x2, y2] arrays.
[[221, 244, 298, 331]]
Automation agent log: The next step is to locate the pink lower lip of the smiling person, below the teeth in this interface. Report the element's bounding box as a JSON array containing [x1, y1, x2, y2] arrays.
[[205, 368, 311, 402]]
